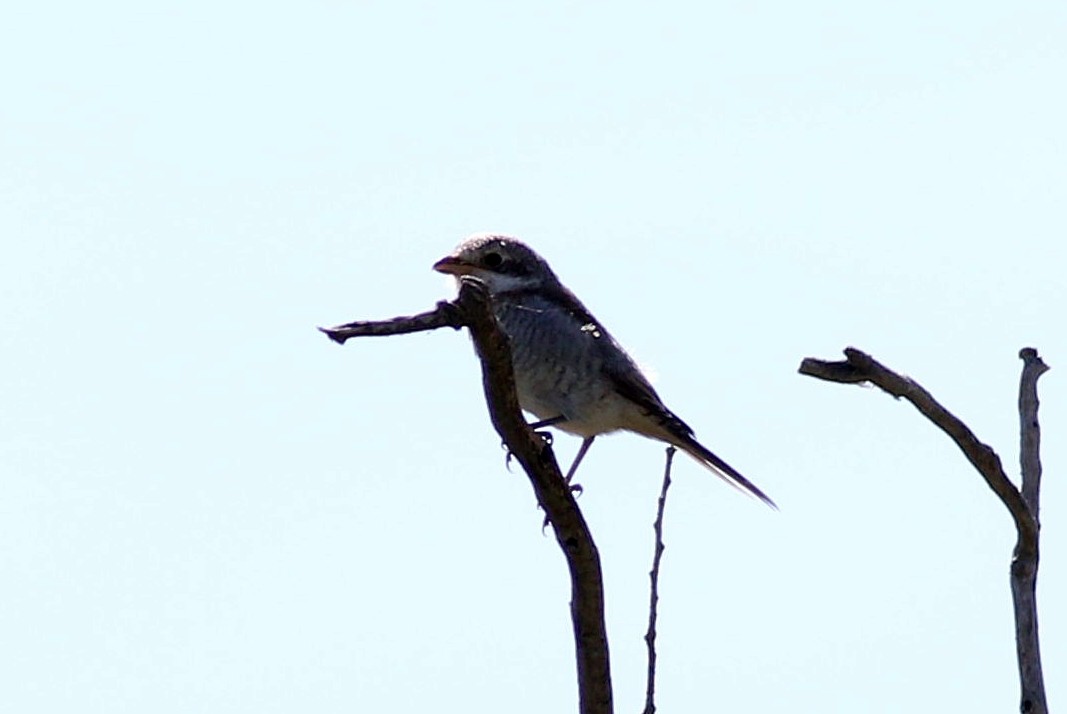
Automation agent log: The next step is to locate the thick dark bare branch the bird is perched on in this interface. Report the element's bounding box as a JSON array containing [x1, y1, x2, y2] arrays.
[[320, 279, 612, 714]]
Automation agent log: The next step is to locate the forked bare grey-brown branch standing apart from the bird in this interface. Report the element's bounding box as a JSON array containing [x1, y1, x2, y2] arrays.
[[799, 347, 1048, 714]]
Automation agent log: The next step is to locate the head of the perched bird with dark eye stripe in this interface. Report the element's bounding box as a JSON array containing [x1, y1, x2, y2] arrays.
[[433, 233, 559, 295]]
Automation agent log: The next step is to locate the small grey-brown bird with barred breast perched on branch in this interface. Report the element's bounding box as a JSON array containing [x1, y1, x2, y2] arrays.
[[433, 233, 778, 510]]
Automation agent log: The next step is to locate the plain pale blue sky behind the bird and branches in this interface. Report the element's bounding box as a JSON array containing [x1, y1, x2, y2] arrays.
[[0, 2, 1067, 714]]
